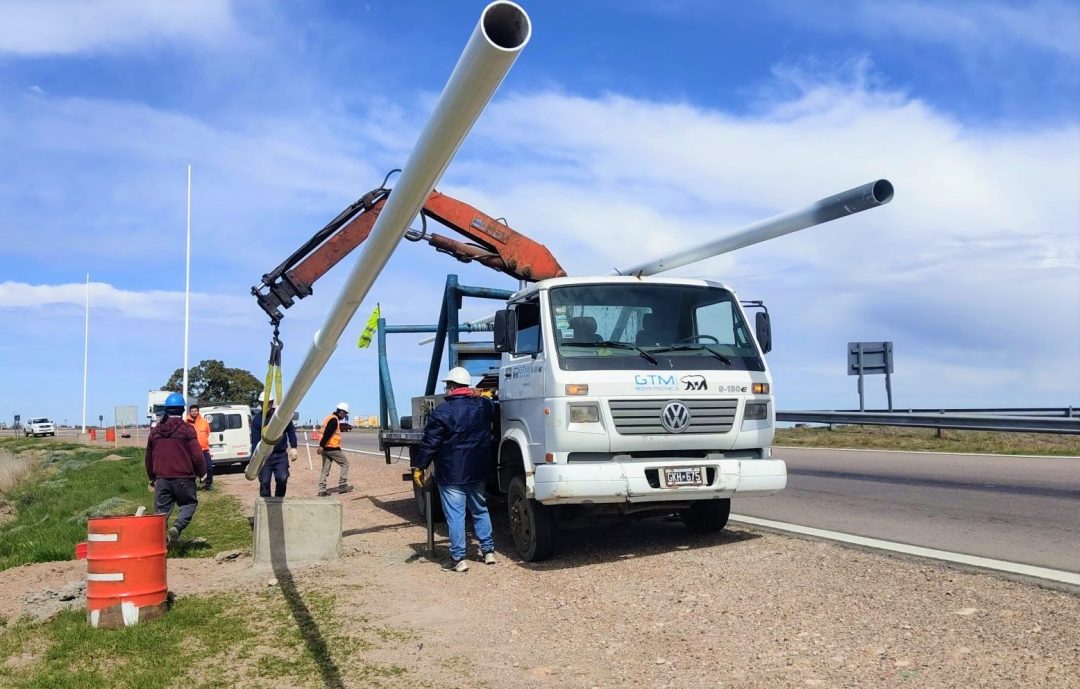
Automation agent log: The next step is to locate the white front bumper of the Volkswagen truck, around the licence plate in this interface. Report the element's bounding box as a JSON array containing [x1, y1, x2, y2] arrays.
[[531, 459, 787, 504]]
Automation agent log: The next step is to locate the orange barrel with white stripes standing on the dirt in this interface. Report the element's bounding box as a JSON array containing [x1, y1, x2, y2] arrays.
[[86, 514, 168, 629]]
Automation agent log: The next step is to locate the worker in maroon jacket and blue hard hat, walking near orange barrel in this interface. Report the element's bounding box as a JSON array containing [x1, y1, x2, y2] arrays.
[[146, 392, 206, 545]]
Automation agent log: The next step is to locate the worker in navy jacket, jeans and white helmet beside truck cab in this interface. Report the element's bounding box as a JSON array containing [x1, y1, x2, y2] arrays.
[[413, 366, 495, 571]]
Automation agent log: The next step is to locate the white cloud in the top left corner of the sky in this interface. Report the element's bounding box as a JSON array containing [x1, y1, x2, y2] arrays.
[[0, 0, 237, 56]]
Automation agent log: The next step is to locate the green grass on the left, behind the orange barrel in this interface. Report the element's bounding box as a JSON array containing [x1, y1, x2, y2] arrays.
[[0, 438, 251, 570]]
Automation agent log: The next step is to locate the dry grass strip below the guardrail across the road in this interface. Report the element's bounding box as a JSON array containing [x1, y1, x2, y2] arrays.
[[774, 425, 1080, 457]]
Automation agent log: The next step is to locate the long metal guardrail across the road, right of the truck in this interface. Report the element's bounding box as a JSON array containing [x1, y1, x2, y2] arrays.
[[777, 409, 1080, 435]]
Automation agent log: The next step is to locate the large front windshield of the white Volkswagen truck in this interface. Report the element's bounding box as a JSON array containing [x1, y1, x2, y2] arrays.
[[550, 283, 765, 370]]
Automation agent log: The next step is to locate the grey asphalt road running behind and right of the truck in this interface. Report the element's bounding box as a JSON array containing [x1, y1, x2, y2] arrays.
[[342, 432, 1080, 572]]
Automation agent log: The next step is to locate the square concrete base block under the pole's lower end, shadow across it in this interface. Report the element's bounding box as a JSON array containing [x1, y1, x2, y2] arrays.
[[252, 498, 342, 565]]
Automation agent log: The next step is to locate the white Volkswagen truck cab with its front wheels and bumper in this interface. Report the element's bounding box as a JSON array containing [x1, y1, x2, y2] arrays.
[[495, 276, 786, 558]]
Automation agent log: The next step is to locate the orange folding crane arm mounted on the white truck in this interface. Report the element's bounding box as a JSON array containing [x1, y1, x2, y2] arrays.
[[252, 181, 566, 324]]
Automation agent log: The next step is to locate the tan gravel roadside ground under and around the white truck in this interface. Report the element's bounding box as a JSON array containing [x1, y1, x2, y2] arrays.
[[0, 444, 1080, 689]]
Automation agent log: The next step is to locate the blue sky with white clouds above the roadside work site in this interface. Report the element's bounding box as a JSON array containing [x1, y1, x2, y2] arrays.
[[0, 0, 1080, 423]]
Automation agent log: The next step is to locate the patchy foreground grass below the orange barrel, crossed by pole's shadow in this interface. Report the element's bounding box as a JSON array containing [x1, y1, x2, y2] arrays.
[[0, 589, 409, 689]]
